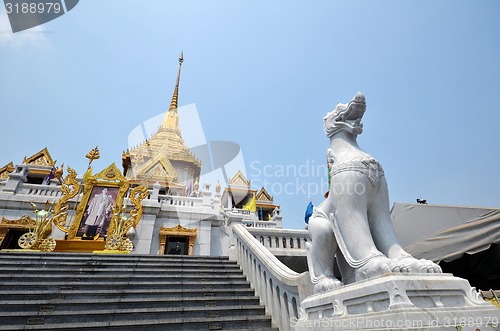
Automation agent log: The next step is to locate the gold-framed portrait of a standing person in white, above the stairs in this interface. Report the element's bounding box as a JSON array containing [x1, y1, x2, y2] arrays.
[[68, 163, 129, 240]]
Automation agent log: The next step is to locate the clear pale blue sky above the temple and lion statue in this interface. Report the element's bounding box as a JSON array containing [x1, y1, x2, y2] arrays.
[[0, 0, 500, 228]]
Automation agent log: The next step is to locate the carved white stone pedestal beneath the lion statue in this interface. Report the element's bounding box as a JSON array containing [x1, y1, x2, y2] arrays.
[[298, 274, 500, 331]]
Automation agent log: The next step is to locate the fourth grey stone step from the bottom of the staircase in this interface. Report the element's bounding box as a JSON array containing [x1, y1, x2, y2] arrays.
[[0, 286, 254, 305]]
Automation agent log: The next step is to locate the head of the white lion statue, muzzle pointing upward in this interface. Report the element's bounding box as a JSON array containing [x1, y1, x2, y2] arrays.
[[323, 92, 366, 138]]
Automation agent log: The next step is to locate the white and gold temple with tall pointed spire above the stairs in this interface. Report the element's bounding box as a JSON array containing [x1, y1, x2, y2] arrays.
[[0, 54, 282, 256]]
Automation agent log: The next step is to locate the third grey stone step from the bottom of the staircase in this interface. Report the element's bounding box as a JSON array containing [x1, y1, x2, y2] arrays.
[[0, 295, 260, 312]]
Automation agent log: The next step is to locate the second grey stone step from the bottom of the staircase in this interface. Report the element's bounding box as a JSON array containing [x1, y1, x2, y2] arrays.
[[0, 305, 265, 325]]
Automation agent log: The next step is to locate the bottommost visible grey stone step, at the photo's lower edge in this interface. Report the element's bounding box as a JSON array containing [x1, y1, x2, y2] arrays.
[[0, 316, 277, 331]]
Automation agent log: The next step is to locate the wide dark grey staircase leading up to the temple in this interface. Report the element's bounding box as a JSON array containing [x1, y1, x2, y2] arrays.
[[0, 252, 277, 331]]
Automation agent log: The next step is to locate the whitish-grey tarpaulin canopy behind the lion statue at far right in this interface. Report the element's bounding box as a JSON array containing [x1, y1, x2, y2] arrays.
[[391, 203, 500, 262]]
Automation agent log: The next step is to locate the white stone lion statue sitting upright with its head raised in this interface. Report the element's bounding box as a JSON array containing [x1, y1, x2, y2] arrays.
[[307, 92, 442, 293]]
